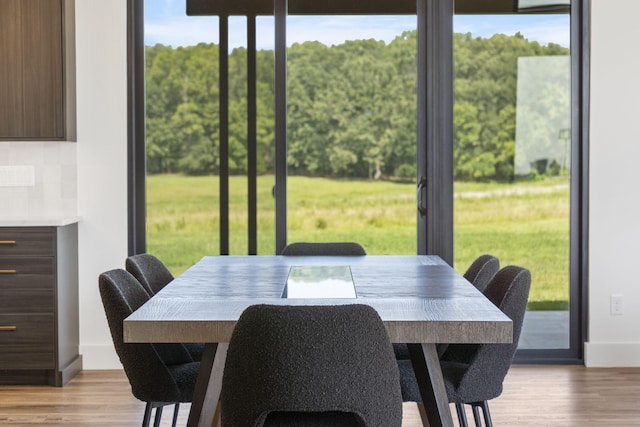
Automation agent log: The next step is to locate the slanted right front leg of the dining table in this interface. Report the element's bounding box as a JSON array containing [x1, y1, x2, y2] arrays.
[[408, 343, 453, 427]]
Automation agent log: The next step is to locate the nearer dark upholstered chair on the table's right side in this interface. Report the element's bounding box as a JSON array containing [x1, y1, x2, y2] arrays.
[[398, 266, 531, 427]]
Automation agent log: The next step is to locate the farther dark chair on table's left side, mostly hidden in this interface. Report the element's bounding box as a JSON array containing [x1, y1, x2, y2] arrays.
[[125, 254, 204, 362]]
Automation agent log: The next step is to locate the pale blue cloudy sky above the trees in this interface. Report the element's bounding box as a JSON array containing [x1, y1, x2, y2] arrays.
[[145, 0, 569, 49]]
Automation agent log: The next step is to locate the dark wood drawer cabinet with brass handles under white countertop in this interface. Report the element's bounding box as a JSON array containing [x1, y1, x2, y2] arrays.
[[0, 224, 82, 386]]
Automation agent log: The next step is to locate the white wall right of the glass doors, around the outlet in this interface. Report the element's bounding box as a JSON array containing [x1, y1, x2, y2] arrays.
[[585, 0, 640, 366]]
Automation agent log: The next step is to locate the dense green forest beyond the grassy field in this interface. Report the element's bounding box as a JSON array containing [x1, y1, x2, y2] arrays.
[[146, 31, 569, 181]]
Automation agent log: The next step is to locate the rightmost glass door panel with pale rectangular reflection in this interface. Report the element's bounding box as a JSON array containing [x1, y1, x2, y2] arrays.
[[454, 14, 571, 349]]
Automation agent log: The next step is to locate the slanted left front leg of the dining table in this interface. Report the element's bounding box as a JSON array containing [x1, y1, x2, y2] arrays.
[[187, 343, 229, 427]]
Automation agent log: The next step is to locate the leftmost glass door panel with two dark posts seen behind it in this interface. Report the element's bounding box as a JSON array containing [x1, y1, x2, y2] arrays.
[[144, 10, 275, 264]]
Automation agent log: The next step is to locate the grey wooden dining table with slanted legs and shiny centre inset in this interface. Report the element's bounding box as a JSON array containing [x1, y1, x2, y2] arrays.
[[123, 255, 513, 427]]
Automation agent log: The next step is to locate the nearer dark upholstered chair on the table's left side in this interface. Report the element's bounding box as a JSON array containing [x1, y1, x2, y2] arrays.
[[98, 269, 200, 427]]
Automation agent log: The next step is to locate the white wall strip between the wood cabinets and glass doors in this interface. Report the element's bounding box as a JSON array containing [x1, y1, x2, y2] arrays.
[[76, 0, 127, 369]]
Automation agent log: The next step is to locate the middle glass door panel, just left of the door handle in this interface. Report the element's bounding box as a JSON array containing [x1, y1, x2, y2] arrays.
[[287, 16, 416, 254]]
